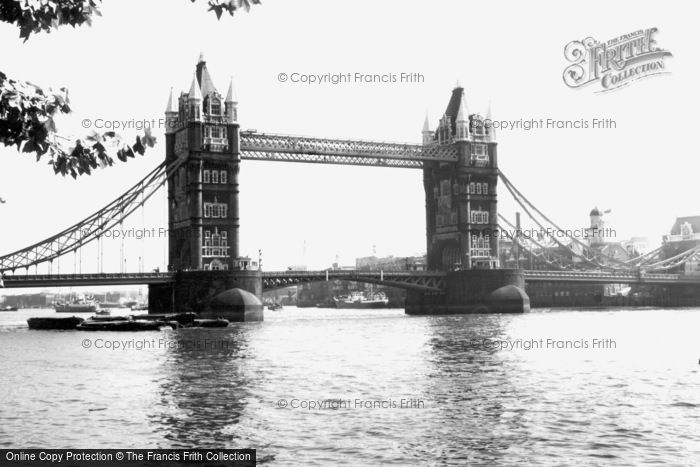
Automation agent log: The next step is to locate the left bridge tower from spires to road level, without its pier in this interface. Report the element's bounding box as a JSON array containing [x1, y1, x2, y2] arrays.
[[165, 56, 243, 270]]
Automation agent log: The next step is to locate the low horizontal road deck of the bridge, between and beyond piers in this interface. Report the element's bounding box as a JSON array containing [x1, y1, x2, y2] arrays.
[[3, 270, 700, 292]]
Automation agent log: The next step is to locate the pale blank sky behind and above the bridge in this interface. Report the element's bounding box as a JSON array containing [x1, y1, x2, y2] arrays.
[[0, 0, 700, 278]]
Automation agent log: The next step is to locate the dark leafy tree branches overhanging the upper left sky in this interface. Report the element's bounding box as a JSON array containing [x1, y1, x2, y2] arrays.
[[0, 0, 260, 178]]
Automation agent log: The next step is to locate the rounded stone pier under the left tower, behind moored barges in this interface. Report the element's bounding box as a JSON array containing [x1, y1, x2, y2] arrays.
[[148, 271, 263, 321]]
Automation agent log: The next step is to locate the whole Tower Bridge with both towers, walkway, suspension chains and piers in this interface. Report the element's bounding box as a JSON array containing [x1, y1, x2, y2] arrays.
[[0, 57, 700, 320]]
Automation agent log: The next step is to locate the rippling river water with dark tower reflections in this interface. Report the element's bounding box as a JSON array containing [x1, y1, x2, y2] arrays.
[[0, 307, 700, 466]]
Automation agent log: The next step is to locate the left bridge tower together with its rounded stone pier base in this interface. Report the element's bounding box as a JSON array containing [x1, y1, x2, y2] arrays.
[[149, 55, 263, 321]]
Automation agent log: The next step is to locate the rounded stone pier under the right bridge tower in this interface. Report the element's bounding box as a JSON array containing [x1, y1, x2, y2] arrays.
[[406, 269, 530, 315]]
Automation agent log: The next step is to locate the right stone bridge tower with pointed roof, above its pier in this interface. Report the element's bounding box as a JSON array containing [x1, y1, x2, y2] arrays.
[[422, 83, 498, 271]]
